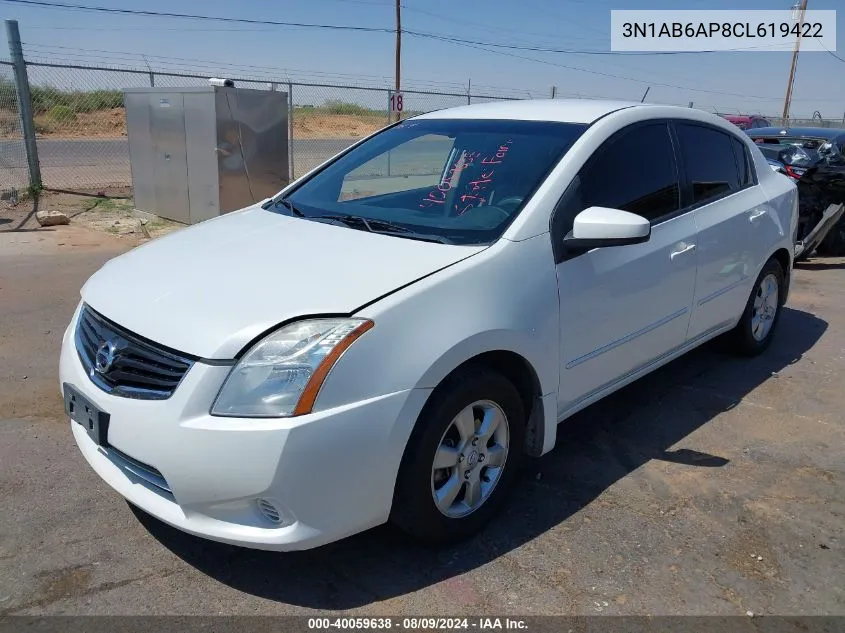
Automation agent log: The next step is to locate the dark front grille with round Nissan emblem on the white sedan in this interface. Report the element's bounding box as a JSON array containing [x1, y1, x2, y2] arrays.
[[76, 305, 195, 400]]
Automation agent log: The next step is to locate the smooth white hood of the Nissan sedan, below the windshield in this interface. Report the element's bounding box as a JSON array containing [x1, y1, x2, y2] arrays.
[[82, 206, 485, 359]]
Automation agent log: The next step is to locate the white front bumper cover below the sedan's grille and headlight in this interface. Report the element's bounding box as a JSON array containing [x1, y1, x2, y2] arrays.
[[60, 306, 430, 550]]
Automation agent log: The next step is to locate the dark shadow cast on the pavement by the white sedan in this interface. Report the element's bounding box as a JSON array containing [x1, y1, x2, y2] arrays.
[[133, 308, 827, 609]]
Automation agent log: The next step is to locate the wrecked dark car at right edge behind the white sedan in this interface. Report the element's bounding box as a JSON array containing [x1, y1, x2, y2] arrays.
[[746, 127, 845, 256]]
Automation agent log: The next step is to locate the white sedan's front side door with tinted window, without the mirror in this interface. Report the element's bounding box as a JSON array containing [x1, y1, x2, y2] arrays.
[[552, 122, 696, 418]]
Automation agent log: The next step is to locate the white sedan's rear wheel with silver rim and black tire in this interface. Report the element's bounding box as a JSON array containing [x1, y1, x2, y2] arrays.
[[732, 258, 784, 356]]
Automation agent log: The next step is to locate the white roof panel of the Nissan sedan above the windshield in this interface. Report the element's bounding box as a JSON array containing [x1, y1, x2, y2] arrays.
[[414, 99, 648, 123]]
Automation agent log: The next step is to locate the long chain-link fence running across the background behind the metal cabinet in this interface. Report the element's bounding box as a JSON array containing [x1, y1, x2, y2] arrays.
[[0, 60, 845, 198]]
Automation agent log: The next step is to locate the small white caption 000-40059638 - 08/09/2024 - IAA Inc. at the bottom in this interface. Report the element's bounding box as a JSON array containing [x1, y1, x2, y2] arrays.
[[308, 617, 528, 631]]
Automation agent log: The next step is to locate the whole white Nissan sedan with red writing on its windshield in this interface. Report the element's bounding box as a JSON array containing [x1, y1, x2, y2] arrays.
[[60, 100, 798, 550]]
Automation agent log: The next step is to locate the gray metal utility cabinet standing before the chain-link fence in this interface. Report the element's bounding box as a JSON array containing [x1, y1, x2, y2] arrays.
[[124, 85, 289, 224]]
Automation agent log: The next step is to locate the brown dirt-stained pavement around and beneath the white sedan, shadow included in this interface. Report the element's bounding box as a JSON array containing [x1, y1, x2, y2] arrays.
[[0, 220, 845, 616]]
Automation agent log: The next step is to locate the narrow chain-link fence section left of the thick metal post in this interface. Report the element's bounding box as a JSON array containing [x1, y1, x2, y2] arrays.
[[0, 60, 29, 194]]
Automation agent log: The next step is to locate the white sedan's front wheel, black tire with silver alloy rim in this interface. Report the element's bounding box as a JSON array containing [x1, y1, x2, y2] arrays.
[[390, 365, 525, 544]]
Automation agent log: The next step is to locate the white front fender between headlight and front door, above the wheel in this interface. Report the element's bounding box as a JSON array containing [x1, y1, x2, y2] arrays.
[[315, 234, 560, 410]]
